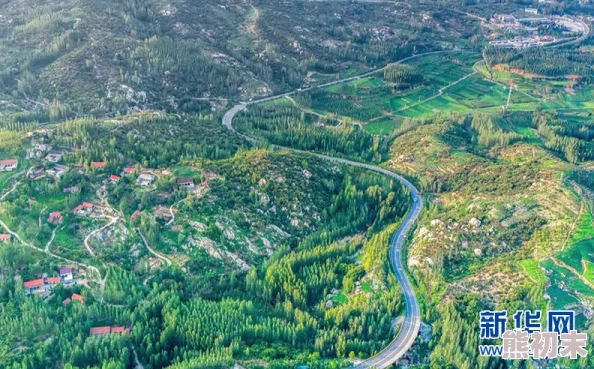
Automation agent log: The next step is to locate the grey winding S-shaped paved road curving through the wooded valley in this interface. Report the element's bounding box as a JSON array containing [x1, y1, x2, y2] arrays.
[[223, 50, 442, 369]]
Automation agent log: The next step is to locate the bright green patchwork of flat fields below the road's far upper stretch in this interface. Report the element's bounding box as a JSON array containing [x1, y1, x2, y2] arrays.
[[302, 52, 594, 126]]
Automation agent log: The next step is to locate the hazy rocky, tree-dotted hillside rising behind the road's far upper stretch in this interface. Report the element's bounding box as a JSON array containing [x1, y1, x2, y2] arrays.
[[0, 0, 480, 122]]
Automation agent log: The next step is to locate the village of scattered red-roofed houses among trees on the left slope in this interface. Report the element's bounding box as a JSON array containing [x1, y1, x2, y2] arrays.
[[0, 134, 217, 336]]
